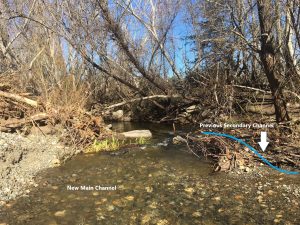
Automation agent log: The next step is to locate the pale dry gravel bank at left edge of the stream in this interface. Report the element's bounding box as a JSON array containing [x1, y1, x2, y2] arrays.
[[0, 132, 78, 206]]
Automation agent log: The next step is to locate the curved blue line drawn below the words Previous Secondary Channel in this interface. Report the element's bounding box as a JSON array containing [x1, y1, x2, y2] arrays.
[[202, 132, 300, 175]]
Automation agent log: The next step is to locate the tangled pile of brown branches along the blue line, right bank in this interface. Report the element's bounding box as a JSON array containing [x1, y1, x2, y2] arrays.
[[186, 130, 300, 172]]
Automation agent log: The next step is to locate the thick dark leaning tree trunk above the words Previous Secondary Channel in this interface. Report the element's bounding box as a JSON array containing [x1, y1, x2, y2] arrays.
[[257, 0, 290, 122]]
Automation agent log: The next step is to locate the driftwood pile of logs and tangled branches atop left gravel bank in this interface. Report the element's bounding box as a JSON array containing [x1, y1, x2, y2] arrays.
[[0, 76, 109, 147]]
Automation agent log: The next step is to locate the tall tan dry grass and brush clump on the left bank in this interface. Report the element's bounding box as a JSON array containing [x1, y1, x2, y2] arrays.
[[0, 72, 107, 147]]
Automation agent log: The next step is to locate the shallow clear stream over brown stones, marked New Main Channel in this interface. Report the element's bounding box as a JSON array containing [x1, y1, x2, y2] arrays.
[[0, 123, 300, 225]]
